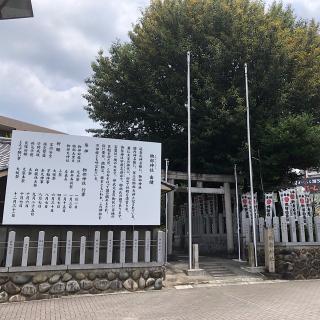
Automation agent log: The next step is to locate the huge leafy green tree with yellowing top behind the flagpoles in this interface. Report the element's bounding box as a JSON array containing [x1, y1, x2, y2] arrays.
[[84, 0, 320, 188]]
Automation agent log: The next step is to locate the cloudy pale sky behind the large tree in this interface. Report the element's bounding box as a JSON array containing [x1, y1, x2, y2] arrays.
[[0, 0, 320, 135]]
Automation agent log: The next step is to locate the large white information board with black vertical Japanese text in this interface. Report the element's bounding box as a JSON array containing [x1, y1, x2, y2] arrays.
[[3, 131, 161, 225]]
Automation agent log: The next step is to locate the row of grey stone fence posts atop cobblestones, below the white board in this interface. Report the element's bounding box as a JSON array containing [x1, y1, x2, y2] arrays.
[[0, 231, 165, 272]]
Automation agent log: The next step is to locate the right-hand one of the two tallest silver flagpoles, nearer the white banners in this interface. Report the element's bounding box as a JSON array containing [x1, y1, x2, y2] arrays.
[[244, 63, 258, 267]]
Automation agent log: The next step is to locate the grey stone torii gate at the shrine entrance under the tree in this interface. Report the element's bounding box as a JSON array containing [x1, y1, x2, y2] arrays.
[[162, 171, 235, 254]]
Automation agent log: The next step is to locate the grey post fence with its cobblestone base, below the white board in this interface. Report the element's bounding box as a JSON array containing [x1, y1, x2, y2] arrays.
[[0, 231, 165, 302]]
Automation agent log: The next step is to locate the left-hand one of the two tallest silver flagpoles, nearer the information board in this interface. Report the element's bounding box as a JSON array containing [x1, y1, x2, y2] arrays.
[[187, 51, 192, 270]]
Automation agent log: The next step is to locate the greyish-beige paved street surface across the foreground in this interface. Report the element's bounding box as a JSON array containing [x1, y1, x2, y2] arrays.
[[0, 280, 320, 320]]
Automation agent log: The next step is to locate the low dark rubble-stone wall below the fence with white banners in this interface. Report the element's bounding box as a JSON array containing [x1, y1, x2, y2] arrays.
[[275, 244, 320, 280]]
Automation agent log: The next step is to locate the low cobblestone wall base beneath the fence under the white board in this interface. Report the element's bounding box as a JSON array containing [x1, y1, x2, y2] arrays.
[[0, 267, 165, 302]]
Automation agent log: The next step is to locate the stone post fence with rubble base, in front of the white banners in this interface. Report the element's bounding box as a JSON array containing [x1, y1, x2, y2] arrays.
[[246, 216, 320, 279]]
